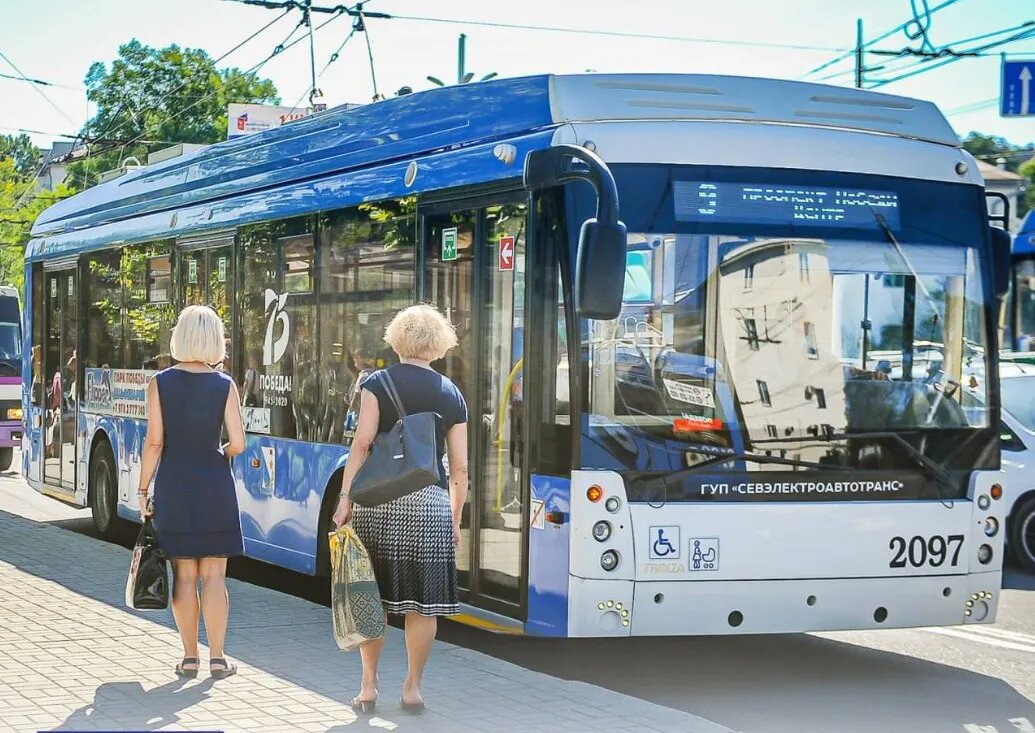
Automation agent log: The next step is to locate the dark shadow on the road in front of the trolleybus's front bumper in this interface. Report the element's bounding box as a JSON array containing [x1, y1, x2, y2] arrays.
[[439, 624, 1035, 733]]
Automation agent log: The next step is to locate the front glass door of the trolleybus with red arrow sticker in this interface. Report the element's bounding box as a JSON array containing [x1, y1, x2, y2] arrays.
[[421, 198, 529, 618]]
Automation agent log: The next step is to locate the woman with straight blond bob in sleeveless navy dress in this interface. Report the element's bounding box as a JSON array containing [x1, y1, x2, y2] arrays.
[[138, 305, 244, 679]]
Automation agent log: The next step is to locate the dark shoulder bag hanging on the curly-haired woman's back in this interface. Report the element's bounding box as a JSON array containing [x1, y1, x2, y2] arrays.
[[349, 371, 441, 506]]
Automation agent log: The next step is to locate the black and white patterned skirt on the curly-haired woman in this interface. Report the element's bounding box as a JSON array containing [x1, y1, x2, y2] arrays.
[[352, 487, 460, 616]]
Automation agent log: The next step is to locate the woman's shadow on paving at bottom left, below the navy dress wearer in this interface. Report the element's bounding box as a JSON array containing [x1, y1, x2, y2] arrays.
[[52, 678, 212, 731]]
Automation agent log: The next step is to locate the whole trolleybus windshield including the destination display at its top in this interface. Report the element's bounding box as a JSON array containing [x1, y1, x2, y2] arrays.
[[583, 166, 989, 488]]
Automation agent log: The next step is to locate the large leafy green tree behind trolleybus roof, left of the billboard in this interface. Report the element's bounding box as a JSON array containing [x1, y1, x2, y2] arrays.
[[69, 40, 280, 188]]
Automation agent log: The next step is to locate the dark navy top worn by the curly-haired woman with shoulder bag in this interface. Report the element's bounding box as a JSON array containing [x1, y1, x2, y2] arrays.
[[360, 363, 467, 489]]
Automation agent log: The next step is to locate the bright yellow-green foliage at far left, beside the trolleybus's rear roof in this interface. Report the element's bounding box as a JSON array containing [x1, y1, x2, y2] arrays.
[[0, 157, 71, 290]]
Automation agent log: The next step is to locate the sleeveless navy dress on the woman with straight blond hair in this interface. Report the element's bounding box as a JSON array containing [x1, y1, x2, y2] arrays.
[[154, 368, 244, 558]]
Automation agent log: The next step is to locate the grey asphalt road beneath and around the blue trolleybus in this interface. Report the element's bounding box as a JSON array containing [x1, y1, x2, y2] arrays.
[[0, 462, 1035, 733]]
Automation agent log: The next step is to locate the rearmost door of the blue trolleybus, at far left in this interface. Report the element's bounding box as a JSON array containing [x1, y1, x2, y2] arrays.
[[42, 267, 82, 492]]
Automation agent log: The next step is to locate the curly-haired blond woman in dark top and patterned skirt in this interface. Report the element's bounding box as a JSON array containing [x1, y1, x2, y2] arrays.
[[334, 305, 468, 713]]
